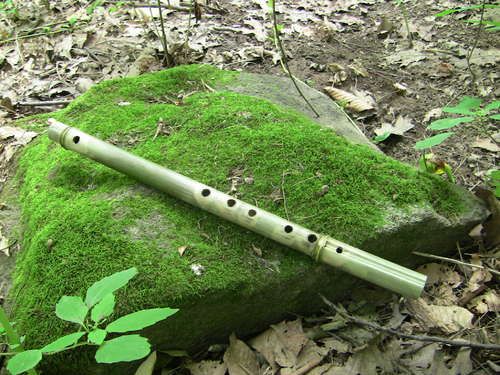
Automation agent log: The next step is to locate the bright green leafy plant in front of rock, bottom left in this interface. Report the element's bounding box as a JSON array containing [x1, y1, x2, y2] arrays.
[[0, 267, 178, 375]]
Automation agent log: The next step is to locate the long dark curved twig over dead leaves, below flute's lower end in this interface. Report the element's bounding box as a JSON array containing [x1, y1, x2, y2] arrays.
[[320, 294, 500, 350]]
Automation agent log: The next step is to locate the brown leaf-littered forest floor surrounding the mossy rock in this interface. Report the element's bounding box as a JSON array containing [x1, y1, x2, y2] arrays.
[[0, 0, 500, 375]]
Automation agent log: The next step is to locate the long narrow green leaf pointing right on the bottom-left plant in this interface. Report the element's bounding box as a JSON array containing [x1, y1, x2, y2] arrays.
[[106, 307, 179, 332]]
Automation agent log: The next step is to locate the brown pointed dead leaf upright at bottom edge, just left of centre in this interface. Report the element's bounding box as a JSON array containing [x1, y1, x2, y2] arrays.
[[224, 333, 260, 375]]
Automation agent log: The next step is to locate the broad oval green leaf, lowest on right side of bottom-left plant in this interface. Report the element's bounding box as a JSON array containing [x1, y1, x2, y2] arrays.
[[95, 335, 151, 363]]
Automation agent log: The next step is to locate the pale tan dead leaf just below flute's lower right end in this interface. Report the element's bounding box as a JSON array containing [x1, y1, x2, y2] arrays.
[[406, 298, 474, 333]]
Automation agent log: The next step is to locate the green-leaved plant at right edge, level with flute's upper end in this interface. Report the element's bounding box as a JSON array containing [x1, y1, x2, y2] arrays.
[[415, 96, 500, 150]]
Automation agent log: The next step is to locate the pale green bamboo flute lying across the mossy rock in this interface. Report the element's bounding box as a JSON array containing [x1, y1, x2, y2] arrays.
[[48, 119, 426, 298]]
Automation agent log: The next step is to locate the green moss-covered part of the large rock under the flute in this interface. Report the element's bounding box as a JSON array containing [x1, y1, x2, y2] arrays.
[[8, 66, 483, 374]]
